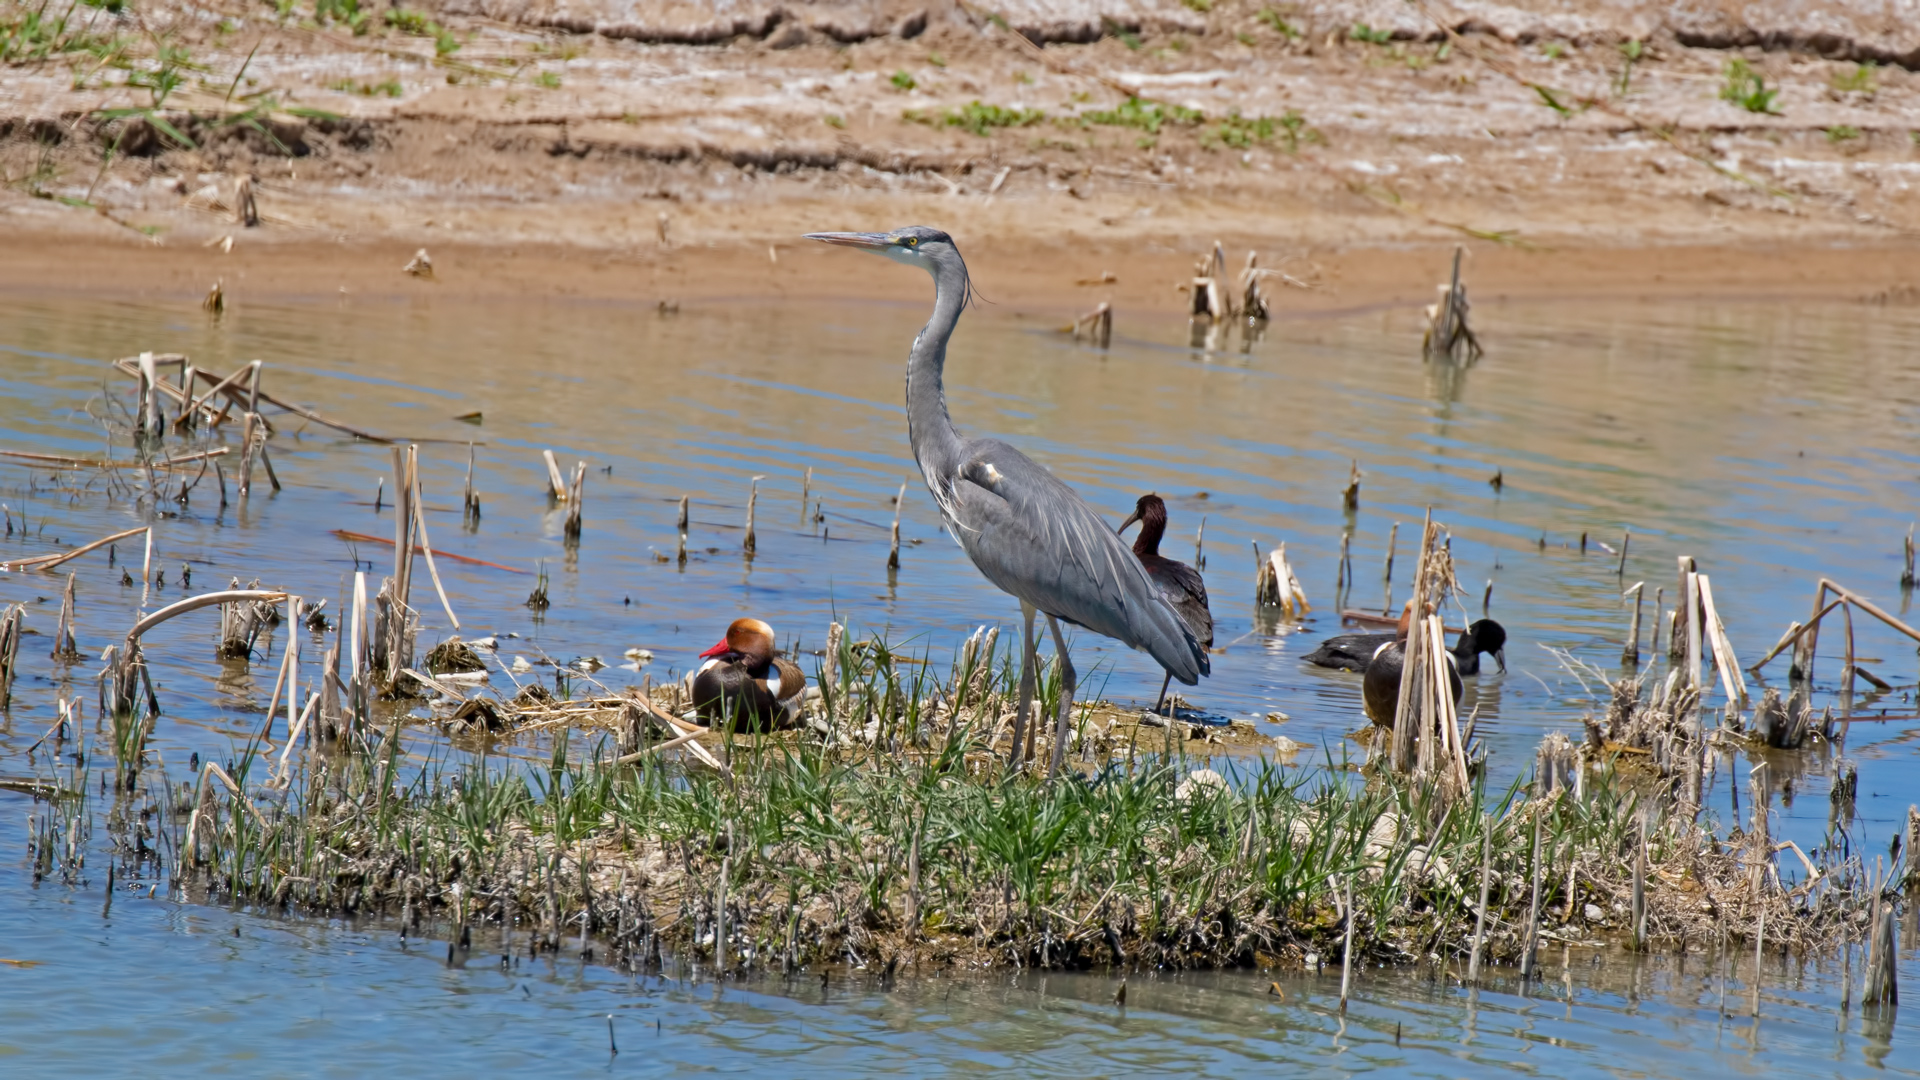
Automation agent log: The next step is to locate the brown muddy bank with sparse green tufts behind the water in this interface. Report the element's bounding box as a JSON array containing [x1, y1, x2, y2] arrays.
[[0, 2, 1920, 292]]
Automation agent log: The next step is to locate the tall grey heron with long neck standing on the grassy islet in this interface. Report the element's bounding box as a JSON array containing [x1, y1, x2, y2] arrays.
[[808, 225, 1208, 776]]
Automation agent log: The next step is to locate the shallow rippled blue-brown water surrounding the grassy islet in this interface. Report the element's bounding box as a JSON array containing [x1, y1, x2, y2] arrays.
[[0, 284, 1920, 1076]]
